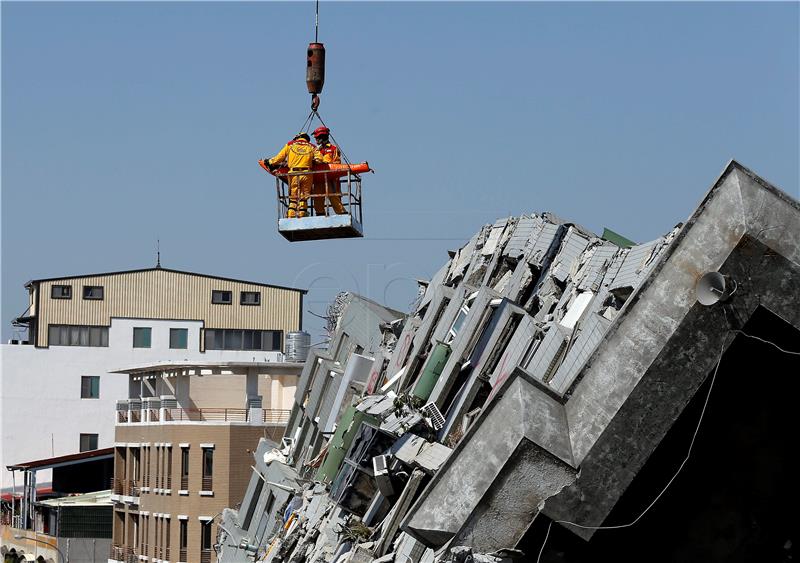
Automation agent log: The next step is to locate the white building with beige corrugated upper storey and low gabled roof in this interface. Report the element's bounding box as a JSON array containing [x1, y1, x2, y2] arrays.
[[0, 267, 305, 493]]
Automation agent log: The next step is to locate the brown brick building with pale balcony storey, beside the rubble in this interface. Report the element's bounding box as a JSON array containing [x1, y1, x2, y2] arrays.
[[109, 361, 302, 563]]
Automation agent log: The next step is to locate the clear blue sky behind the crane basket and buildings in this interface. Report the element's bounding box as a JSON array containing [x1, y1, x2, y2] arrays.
[[0, 1, 800, 339]]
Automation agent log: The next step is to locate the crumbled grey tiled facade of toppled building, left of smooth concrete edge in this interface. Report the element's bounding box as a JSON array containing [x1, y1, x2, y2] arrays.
[[220, 208, 677, 563]]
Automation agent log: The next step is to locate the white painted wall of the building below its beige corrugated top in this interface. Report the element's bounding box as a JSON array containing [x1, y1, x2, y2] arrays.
[[0, 319, 283, 492]]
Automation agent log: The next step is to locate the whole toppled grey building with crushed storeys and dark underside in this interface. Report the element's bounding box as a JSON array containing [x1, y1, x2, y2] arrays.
[[218, 162, 800, 563]]
